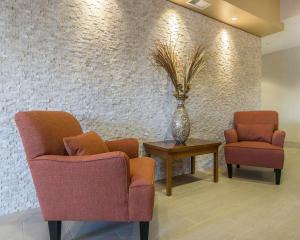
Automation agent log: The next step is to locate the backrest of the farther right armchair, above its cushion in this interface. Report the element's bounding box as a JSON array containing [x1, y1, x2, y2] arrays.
[[234, 111, 278, 130]]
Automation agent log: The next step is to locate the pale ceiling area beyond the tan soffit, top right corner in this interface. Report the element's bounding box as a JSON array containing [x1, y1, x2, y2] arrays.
[[262, 0, 300, 55]]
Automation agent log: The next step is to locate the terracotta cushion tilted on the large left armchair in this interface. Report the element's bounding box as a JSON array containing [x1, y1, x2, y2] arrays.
[[63, 131, 109, 156]]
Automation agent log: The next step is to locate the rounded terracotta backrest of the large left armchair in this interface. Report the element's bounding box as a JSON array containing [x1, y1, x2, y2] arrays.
[[15, 111, 82, 160]]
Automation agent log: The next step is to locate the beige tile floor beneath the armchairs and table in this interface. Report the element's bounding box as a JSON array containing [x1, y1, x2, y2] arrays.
[[0, 148, 300, 240]]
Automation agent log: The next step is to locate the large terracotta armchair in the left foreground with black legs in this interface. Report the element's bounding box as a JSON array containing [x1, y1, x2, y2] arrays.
[[15, 111, 154, 240]]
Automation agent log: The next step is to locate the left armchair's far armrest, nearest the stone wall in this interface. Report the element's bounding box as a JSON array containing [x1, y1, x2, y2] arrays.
[[106, 138, 139, 158]]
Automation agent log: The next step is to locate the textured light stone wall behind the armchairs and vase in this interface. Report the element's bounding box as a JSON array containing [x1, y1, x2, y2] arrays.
[[0, 0, 261, 215]]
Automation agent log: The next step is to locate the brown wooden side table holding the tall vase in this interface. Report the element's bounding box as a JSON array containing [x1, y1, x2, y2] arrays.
[[144, 139, 221, 196]]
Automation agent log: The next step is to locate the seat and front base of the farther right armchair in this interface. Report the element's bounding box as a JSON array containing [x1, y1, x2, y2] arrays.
[[225, 141, 284, 169]]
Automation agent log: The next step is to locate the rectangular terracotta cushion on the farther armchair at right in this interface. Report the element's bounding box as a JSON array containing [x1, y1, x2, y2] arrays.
[[237, 124, 274, 143]]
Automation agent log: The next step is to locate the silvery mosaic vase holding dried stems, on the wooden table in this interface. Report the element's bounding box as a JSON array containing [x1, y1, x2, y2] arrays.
[[172, 98, 191, 144]]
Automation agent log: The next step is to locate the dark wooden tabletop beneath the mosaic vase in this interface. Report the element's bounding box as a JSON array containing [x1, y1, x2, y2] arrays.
[[144, 138, 222, 152]]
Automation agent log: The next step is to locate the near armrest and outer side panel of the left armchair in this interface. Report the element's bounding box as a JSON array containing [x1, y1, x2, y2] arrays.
[[29, 152, 130, 221]]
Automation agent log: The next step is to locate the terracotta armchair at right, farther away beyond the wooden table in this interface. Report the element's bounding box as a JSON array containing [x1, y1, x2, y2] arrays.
[[224, 111, 285, 185]]
